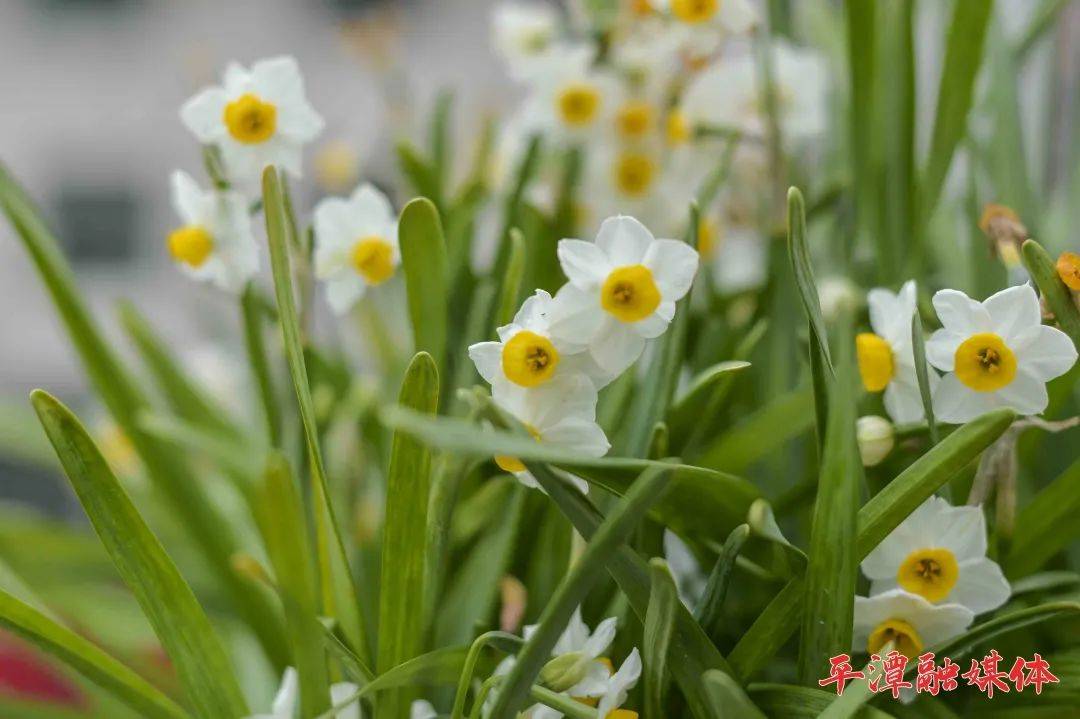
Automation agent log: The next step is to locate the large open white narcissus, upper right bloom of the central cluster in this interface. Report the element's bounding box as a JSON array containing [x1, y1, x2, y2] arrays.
[[551, 216, 698, 375]]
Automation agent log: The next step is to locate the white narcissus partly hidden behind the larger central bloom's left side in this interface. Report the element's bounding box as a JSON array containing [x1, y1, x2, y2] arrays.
[[469, 289, 613, 392]]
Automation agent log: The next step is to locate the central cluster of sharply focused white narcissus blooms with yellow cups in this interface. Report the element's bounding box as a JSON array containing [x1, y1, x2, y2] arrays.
[[469, 216, 698, 491]]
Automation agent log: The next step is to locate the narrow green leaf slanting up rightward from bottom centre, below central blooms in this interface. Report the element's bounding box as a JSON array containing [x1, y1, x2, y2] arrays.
[[491, 464, 667, 717]]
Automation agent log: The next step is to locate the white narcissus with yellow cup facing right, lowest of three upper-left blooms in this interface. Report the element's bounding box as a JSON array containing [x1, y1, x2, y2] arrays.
[[315, 182, 401, 315]]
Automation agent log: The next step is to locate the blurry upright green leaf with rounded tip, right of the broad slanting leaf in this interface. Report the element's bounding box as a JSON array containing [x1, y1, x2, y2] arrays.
[[257, 452, 329, 717]]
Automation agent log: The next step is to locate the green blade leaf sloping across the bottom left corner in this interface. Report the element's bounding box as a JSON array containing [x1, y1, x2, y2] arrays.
[[0, 589, 188, 719]]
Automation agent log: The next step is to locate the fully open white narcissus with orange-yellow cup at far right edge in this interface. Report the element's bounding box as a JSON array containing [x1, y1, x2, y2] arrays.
[[927, 285, 1077, 423]]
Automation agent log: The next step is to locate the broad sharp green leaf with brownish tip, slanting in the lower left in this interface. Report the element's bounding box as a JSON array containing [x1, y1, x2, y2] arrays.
[[30, 390, 247, 719]]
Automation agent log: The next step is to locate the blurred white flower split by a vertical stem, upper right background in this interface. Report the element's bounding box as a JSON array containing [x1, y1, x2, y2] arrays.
[[680, 41, 828, 141]]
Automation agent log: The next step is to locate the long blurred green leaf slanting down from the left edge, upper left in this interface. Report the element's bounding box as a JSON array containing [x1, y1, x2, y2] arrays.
[[0, 159, 287, 667]]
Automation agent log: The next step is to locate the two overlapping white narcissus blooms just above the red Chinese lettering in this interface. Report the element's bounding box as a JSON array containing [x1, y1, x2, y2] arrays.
[[853, 497, 1010, 660]]
